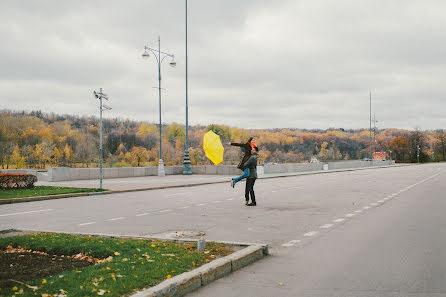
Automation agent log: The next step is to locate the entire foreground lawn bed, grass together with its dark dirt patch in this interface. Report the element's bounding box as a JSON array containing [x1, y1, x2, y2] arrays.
[[0, 233, 233, 297]]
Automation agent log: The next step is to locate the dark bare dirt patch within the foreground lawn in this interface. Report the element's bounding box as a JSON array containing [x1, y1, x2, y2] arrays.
[[0, 251, 94, 288]]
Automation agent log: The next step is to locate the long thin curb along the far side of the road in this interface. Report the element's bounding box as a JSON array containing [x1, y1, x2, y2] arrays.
[[0, 164, 404, 205]]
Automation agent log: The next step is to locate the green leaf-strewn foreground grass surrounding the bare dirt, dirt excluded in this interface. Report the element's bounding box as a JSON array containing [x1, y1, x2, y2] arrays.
[[0, 233, 230, 296]]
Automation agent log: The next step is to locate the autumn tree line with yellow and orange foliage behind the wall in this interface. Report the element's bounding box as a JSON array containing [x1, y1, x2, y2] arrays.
[[0, 110, 446, 169]]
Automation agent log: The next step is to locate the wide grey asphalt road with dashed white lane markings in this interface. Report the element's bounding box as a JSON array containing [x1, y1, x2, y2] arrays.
[[0, 164, 446, 297]]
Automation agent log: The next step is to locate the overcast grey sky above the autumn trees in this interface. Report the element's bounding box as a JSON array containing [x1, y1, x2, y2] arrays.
[[0, 0, 446, 130]]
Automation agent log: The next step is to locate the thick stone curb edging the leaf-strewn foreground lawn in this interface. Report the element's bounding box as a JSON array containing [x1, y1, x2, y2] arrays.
[[130, 245, 268, 297]]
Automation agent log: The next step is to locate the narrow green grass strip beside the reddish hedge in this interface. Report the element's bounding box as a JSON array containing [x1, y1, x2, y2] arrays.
[[0, 186, 104, 198]]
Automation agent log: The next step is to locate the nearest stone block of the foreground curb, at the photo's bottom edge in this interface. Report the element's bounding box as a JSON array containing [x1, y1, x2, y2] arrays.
[[131, 270, 201, 297]]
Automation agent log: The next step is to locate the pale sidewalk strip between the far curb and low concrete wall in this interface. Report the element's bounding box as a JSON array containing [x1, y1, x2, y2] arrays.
[[36, 165, 407, 191]]
